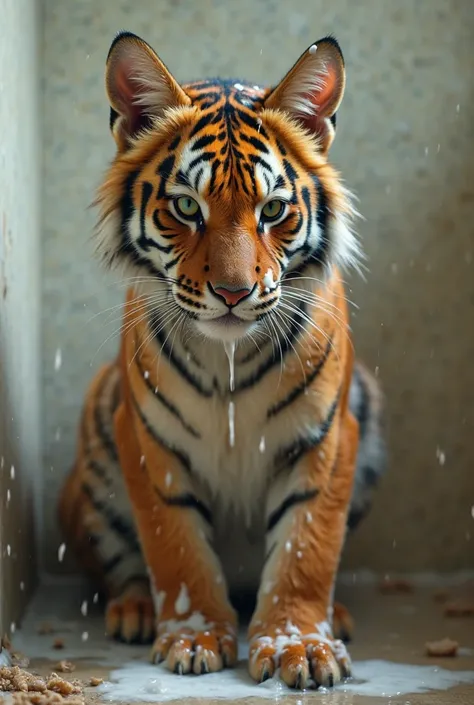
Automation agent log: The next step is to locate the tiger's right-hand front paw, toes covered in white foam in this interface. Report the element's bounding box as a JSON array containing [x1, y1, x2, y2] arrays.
[[249, 627, 351, 689]]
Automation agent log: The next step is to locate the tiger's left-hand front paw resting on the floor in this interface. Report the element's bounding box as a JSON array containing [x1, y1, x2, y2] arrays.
[[152, 629, 237, 675]]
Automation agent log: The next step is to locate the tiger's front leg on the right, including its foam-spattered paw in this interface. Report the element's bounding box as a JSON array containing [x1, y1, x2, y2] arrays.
[[249, 413, 358, 688]]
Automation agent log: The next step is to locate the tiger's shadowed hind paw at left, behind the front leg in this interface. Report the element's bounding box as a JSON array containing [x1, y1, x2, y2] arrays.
[[105, 583, 155, 644]]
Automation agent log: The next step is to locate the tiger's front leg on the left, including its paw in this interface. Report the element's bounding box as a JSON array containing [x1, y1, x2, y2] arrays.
[[111, 402, 237, 674]]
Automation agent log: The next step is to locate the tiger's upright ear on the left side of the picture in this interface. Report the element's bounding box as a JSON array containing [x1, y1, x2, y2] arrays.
[[105, 32, 191, 149]]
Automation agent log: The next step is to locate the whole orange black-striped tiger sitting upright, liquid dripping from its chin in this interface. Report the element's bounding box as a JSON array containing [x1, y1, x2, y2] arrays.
[[60, 33, 385, 688]]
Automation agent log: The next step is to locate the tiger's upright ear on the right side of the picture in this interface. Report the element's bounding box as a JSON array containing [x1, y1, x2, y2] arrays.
[[265, 37, 346, 152]]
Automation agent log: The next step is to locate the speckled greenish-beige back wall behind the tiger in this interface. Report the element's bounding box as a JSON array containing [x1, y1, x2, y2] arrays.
[[43, 0, 474, 571]]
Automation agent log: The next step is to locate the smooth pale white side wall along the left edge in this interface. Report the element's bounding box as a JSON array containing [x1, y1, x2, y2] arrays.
[[0, 0, 41, 633]]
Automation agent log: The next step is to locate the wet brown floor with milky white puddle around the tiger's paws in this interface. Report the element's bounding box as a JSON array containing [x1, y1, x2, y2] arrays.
[[6, 576, 474, 705]]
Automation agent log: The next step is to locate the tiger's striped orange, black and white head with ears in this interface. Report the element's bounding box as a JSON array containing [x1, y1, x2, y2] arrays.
[[97, 33, 358, 341]]
